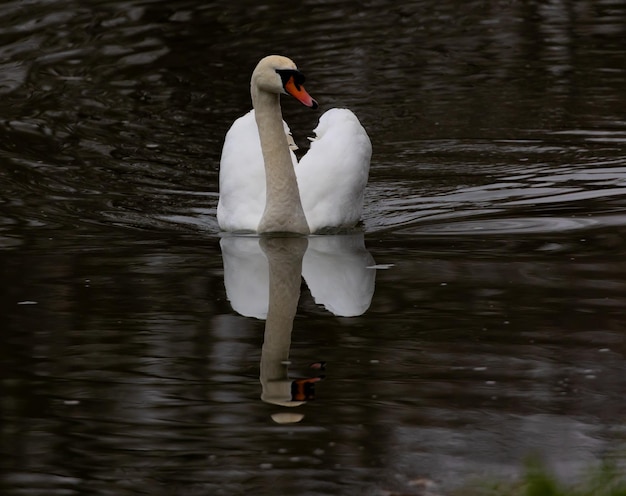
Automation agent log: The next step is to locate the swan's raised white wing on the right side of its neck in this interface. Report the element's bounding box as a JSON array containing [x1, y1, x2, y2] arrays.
[[296, 109, 372, 232]]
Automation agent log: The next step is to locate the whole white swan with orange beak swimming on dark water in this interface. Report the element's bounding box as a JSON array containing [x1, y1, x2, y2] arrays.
[[217, 55, 372, 234]]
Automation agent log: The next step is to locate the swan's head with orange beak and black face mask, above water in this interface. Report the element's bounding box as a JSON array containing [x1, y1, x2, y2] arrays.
[[250, 55, 317, 109]]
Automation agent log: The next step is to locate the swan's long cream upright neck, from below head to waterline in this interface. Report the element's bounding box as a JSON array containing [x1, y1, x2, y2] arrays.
[[251, 85, 310, 234]]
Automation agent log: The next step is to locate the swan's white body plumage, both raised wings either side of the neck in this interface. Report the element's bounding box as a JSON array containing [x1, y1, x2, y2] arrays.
[[217, 109, 372, 232]]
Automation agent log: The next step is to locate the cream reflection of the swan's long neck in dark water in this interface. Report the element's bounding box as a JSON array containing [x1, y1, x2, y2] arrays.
[[260, 237, 307, 406]]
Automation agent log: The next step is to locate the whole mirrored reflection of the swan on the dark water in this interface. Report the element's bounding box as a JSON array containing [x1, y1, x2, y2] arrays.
[[220, 234, 375, 416]]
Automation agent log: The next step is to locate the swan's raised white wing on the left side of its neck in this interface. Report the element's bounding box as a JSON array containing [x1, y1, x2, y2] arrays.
[[217, 110, 297, 231]]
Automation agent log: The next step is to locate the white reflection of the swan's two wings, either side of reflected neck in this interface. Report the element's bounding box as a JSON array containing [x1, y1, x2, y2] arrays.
[[220, 233, 376, 319]]
